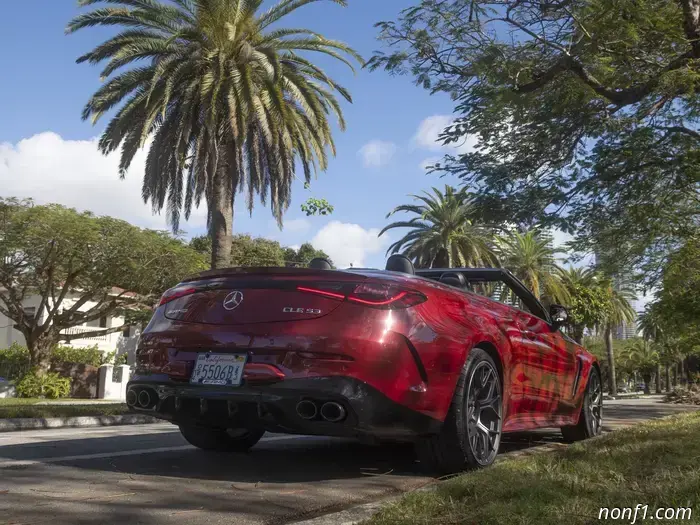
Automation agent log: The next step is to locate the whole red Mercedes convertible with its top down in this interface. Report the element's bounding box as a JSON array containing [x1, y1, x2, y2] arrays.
[[127, 255, 603, 472]]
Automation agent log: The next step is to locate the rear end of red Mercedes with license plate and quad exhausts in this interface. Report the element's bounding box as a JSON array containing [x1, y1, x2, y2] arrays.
[[127, 268, 440, 440]]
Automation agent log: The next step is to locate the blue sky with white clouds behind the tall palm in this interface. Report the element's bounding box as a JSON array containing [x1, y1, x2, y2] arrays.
[[0, 0, 563, 267]]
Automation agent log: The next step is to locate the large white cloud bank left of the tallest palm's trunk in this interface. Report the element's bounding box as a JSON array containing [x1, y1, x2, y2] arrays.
[[0, 132, 206, 230]]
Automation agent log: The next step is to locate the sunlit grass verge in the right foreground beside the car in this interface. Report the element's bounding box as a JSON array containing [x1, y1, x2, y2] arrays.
[[364, 412, 700, 525]]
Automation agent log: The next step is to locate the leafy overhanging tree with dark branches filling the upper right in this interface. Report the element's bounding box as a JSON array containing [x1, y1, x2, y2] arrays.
[[368, 0, 700, 284]]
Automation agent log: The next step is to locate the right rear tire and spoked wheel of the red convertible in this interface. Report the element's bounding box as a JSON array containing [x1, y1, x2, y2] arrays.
[[416, 348, 503, 474]]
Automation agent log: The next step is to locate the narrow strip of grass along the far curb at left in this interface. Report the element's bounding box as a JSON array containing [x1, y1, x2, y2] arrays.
[[0, 398, 129, 419]]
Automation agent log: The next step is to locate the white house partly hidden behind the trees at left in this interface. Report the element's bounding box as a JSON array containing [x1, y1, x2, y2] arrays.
[[0, 290, 138, 363]]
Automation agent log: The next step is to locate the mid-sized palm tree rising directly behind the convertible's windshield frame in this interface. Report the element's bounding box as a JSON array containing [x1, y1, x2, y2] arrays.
[[379, 186, 498, 268]]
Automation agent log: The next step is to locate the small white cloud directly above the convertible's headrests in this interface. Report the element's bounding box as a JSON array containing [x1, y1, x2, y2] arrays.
[[311, 221, 389, 268]]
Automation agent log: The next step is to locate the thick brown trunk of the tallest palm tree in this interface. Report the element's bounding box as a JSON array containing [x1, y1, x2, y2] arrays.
[[209, 155, 233, 269]]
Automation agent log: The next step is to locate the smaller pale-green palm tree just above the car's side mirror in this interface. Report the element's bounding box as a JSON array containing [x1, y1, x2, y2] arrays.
[[497, 228, 569, 303]]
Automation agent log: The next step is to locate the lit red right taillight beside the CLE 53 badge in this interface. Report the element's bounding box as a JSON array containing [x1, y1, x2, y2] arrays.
[[297, 283, 427, 310]]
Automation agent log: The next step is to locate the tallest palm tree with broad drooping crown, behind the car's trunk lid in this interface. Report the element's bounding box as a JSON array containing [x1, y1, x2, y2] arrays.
[[66, 0, 362, 267]]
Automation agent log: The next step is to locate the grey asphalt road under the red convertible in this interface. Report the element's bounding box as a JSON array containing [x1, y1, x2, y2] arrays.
[[0, 400, 693, 525]]
